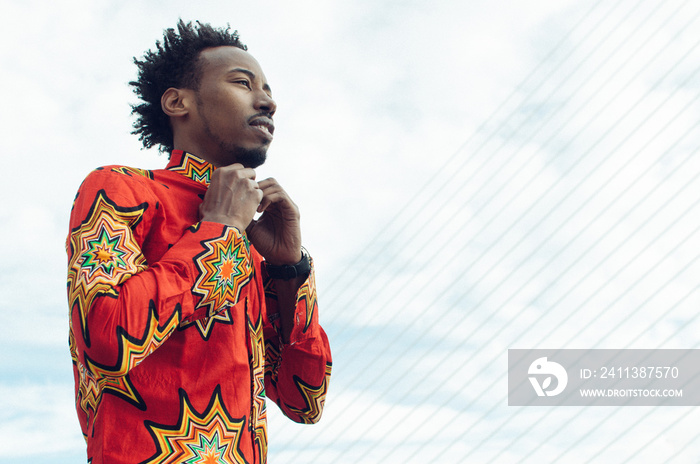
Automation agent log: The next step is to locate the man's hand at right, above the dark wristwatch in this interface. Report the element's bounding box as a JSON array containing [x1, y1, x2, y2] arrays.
[[246, 178, 302, 266]]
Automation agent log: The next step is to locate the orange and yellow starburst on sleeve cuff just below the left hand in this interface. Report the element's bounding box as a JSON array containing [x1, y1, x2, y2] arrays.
[[192, 227, 252, 316]]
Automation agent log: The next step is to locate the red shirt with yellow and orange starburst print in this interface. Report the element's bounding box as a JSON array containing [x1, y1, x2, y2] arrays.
[[66, 150, 331, 464]]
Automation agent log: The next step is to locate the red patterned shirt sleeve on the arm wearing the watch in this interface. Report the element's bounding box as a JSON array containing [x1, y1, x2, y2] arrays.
[[263, 263, 332, 424]]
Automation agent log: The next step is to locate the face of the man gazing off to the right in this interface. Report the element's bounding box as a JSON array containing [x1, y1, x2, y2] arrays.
[[192, 46, 277, 167]]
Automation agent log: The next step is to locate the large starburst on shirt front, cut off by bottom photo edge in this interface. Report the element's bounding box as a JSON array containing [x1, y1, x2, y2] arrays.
[[141, 386, 247, 464]]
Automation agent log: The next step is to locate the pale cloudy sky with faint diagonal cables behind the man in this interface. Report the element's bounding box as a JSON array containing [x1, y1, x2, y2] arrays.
[[0, 0, 700, 464]]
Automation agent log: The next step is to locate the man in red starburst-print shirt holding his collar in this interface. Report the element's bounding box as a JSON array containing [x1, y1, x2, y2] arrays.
[[67, 21, 331, 464]]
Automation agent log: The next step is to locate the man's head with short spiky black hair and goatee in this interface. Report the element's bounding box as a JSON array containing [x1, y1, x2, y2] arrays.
[[131, 21, 276, 167]]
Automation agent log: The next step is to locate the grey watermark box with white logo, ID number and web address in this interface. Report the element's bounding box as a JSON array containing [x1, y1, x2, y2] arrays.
[[508, 348, 700, 406]]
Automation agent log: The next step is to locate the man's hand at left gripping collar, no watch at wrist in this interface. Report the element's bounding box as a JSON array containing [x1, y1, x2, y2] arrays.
[[199, 163, 263, 232]]
